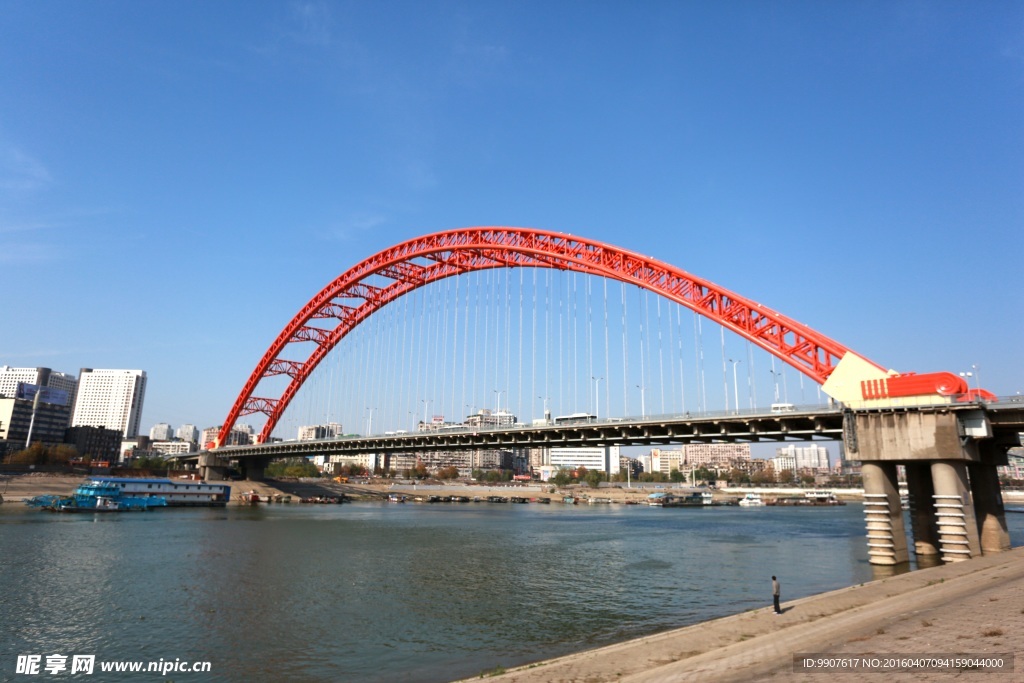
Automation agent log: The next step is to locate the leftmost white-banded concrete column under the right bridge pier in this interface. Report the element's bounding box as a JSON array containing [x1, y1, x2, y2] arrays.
[[860, 462, 910, 564]]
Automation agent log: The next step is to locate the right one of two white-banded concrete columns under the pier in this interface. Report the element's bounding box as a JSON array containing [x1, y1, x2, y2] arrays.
[[932, 460, 981, 562]]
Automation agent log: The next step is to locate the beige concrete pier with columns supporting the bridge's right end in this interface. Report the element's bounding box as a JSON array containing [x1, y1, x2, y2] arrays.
[[844, 410, 1010, 565]]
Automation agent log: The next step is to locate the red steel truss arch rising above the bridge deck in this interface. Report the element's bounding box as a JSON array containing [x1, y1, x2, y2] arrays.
[[217, 227, 868, 445]]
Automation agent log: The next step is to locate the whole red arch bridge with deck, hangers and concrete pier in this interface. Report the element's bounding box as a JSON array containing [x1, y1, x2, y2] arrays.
[[190, 227, 1021, 564]]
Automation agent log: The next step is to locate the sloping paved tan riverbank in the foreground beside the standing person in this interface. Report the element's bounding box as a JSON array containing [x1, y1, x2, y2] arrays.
[[466, 548, 1024, 683]]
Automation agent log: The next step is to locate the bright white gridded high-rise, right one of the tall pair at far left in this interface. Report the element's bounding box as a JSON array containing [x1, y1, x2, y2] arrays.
[[71, 368, 145, 438]]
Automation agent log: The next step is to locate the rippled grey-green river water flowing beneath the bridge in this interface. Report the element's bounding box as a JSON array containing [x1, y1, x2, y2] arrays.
[[0, 503, 1024, 681]]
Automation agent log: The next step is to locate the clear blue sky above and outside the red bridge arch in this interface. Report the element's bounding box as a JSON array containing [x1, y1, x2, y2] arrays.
[[0, 0, 1024, 430]]
